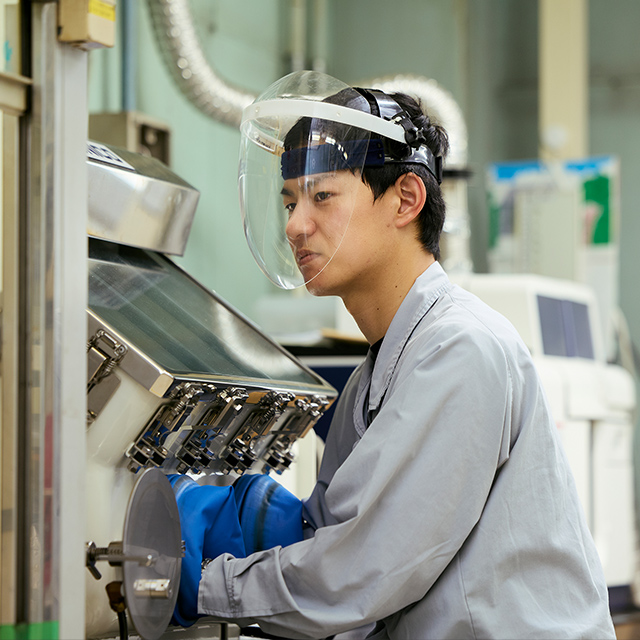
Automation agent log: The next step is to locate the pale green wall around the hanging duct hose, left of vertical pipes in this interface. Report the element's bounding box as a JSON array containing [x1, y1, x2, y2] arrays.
[[89, 0, 283, 316]]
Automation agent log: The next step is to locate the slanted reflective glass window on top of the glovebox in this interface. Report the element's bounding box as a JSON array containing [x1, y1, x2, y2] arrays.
[[89, 239, 322, 385]]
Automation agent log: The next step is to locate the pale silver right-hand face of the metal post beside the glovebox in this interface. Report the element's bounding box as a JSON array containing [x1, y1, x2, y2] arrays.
[[56, 46, 89, 638]]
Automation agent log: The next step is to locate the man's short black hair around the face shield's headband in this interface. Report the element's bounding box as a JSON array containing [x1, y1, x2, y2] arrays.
[[285, 89, 449, 260]]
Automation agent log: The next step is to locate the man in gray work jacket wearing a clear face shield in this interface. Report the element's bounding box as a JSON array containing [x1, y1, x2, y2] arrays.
[[186, 73, 615, 639]]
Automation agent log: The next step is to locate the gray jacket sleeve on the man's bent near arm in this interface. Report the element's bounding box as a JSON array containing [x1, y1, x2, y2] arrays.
[[199, 331, 512, 638]]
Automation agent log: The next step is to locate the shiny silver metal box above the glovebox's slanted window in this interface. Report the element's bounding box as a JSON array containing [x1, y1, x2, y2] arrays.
[[87, 142, 200, 255]]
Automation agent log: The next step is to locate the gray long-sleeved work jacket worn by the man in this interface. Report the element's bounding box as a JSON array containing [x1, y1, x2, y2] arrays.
[[199, 263, 615, 640]]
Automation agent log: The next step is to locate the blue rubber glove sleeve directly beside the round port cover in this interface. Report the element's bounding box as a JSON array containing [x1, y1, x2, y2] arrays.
[[168, 475, 246, 627]]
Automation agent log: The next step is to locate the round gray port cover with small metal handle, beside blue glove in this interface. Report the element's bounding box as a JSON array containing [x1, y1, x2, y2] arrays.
[[122, 469, 182, 640]]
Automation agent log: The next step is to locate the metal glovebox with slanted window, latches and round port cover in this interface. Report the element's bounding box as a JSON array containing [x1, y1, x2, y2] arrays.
[[86, 143, 337, 638]]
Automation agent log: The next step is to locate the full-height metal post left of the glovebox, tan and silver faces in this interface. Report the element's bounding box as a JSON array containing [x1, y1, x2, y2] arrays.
[[16, 2, 87, 638]]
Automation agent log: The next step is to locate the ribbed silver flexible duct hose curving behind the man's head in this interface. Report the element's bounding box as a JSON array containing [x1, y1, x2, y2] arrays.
[[148, 0, 467, 169]]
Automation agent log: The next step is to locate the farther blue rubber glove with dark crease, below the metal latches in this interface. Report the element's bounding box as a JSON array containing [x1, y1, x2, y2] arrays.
[[233, 474, 303, 555]]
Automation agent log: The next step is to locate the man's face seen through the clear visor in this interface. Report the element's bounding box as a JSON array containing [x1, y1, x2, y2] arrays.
[[282, 171, 392, 295]]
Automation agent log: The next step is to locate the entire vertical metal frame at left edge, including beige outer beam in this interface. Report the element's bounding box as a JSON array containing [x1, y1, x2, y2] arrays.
[[0, 2, 88, 638]]
